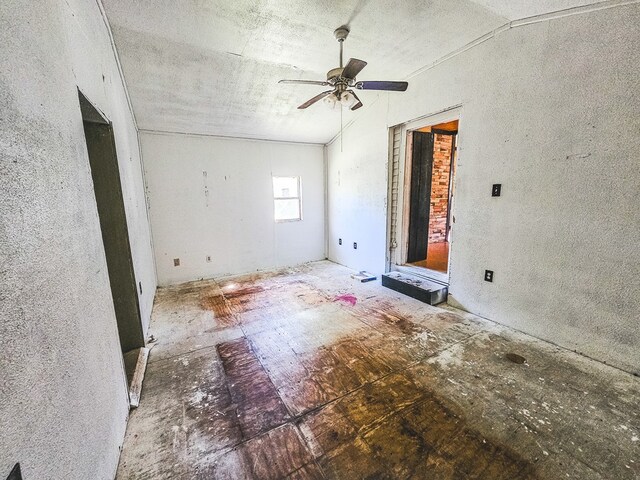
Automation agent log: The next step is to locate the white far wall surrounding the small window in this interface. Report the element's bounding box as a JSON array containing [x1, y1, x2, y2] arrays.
[[141, 132, 325, 285]]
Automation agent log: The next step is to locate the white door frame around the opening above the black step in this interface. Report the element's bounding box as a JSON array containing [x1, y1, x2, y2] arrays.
[[385, 104, 462, 282]]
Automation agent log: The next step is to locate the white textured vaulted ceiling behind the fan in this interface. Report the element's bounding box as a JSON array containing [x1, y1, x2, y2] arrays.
[[103, 0, 595, 143]]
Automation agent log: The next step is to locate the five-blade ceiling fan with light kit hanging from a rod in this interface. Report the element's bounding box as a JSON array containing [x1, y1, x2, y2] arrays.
[[278, 26, 409, 110]]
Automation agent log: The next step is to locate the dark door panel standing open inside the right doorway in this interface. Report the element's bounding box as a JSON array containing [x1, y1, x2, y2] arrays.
[[407, 132, 433, 263]]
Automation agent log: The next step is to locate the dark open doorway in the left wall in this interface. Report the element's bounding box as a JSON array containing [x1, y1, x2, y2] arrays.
[[78, 91, 144, 368]]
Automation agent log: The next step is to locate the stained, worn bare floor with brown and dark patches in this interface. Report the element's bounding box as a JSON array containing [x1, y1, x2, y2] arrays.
[[118, 262, 640, 480]]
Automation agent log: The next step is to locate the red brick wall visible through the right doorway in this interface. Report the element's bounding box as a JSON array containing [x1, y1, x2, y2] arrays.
[[429, 133, 453, 243]]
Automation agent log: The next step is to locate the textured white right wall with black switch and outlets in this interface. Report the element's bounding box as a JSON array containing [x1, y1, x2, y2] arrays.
[[328, 3, 640, 372]]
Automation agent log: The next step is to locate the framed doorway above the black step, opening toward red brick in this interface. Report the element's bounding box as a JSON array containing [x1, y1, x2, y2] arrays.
[[387, 108, 459, 284]]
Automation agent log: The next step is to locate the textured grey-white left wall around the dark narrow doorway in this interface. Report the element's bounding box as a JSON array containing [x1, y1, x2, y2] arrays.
[[0, 0, 155, 479]]
